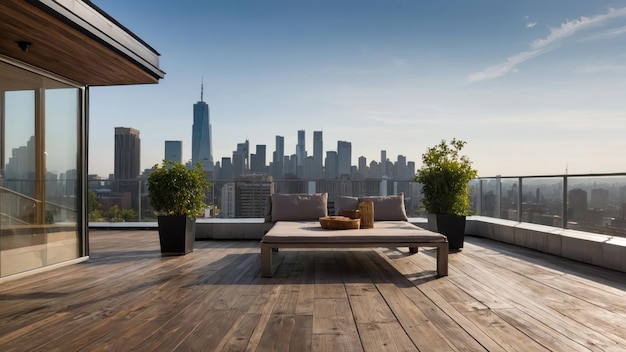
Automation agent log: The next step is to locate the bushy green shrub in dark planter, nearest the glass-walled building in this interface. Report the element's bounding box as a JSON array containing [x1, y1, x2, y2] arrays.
[[148, 160, 211, 255]]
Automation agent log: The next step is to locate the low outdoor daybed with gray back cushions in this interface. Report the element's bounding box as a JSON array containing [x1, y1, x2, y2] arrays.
[[261, 193, 448, 277]]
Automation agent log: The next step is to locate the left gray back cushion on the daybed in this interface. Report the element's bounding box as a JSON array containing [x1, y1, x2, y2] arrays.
[[272, 193, 328, 222]]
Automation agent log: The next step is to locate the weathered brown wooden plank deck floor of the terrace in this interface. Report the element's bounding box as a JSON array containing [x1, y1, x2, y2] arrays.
[[0, 231, 626, 352]]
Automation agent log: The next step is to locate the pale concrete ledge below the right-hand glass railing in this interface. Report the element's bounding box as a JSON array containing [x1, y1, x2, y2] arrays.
[[465, 216, 626, 272]]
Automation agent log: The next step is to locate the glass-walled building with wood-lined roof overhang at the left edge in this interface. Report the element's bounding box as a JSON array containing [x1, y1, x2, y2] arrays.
[[0, 0, 164, 282]]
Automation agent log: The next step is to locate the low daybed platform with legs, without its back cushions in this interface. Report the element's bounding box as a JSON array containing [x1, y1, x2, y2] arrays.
[[261, 221, 448, 277]]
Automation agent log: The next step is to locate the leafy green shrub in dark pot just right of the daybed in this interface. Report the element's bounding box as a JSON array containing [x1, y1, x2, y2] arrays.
[[415, 139, 478, 249]]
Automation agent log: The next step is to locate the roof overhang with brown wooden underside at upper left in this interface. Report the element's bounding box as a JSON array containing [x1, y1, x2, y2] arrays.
[[0, 0, 165, 86]]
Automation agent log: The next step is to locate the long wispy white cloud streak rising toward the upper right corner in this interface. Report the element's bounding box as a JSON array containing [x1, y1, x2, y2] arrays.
[[467, 7, 626, 82]]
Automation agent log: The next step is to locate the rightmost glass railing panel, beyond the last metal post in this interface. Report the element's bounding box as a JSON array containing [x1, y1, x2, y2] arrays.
[[567, 176, 626, 237]]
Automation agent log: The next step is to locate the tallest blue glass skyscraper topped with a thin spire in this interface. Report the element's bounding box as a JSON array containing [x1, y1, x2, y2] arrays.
[[191, 85, 213, 171]]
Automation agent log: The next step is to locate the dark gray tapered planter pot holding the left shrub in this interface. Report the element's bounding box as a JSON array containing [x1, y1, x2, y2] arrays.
[[157, 215, 196, 256]]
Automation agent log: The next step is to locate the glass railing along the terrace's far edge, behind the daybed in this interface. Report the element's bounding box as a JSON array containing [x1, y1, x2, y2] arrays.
[[88, 179, 425, 222]]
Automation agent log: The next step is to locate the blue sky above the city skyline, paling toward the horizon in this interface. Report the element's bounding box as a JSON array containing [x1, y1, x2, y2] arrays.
[[89, 0, 626, 176]]
